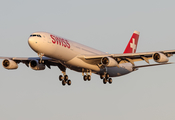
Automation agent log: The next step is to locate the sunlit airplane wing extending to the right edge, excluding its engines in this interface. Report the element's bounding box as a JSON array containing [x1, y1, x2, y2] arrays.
[[79, 50, 175, 65]]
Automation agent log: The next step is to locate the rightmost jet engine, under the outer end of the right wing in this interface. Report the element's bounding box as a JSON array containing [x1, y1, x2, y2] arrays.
[[153, 53, 169, 63]]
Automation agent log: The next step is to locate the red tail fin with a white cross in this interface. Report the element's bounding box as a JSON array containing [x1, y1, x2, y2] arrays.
[[123, 31, 140, 53]]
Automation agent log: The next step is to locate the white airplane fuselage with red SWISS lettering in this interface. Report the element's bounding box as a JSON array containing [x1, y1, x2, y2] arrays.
[[28, 32, 133, 77]]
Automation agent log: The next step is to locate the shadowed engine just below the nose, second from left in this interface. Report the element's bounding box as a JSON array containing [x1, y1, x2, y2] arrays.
[[29, 60, 45, 70]]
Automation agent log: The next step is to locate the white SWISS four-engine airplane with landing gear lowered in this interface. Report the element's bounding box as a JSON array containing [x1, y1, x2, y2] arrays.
[[0, 31, 175, 86]]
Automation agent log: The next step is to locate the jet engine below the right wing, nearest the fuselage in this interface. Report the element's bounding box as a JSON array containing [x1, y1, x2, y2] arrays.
[[101, 57, 119, 67]]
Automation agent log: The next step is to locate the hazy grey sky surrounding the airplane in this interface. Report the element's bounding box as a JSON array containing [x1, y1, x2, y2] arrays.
[[0, 0, 175, 120]]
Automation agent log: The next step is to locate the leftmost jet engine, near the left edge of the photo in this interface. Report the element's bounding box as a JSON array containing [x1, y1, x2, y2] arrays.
[[2, 59, 18, 70]]
